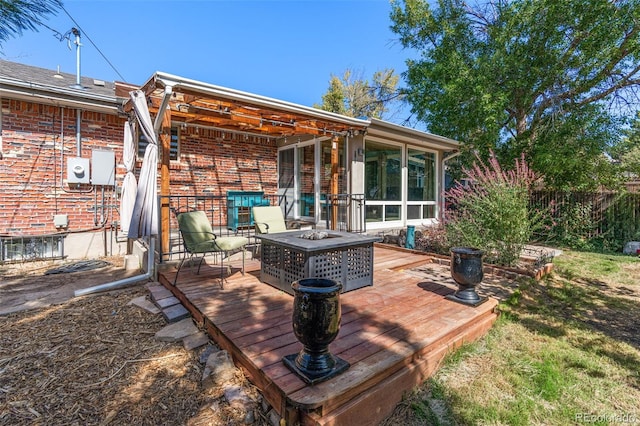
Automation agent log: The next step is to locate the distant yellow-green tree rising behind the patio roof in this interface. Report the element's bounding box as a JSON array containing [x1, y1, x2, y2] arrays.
[[315, 69, 402, 118]]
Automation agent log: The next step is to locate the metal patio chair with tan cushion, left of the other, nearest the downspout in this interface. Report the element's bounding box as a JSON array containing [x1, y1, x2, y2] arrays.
[[173, 211, 249, 287]]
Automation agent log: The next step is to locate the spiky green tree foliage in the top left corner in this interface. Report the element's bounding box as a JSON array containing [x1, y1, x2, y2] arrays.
[[0, 0, 62, 46]]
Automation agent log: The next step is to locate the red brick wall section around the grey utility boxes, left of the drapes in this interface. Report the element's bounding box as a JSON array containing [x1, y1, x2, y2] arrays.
[[0, 99, 124, 236]]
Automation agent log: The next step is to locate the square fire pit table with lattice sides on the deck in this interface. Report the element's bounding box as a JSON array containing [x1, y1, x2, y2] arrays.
[[256, 230, 381, 294]]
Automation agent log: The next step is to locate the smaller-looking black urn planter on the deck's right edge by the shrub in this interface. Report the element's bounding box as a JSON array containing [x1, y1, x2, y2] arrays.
[[446, 247, 487, 306]]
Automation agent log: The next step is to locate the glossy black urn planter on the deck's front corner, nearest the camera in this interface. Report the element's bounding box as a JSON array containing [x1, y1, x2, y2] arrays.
[[282, 278, 349, 385]]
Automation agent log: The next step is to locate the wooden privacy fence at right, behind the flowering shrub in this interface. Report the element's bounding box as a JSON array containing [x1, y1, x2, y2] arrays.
[[530, 191, 640, 250]]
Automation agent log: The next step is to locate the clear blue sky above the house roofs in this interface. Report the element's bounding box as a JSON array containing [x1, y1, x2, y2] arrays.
[[0, 0, 412, 121]]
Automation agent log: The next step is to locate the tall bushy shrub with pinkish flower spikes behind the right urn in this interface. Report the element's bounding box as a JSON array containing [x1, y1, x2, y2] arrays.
[[445, 155, 540, 266]]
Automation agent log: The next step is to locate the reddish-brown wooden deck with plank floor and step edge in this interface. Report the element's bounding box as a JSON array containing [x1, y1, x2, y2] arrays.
[[160, 245, 497, 425]]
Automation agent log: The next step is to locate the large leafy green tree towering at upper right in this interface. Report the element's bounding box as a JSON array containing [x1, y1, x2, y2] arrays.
[[391, 0, 640, 189]]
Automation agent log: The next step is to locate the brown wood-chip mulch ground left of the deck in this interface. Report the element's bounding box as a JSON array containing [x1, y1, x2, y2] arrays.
[[0, 285, 264, 425]]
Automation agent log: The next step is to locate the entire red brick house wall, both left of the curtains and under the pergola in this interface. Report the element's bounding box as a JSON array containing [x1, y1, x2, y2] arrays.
[[0, 99, 277, 236]]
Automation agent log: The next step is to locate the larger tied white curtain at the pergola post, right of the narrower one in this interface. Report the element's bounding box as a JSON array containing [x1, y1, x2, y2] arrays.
[[128, 90, 158, 238]]
